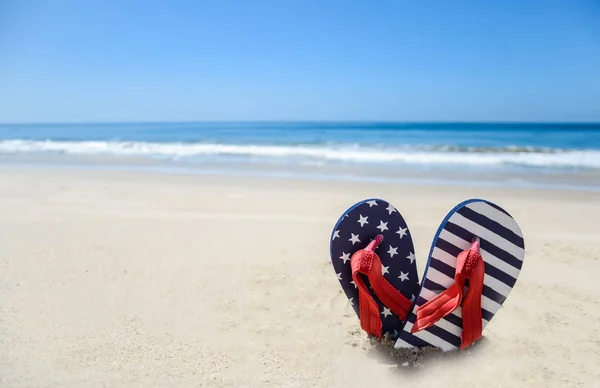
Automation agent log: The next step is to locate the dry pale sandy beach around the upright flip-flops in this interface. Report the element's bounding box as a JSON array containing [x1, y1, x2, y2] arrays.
[[0, 167, 600, 388]]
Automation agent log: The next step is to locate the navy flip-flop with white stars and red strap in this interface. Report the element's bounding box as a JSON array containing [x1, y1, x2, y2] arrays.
[[330, 198, 419, 339]]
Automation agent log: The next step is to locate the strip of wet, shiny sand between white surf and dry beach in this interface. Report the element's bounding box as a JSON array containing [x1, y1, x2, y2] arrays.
[[0, 158, 600, 192]]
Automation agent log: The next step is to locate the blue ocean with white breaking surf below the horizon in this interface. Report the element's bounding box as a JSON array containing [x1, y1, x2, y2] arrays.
[[0, 122, 600, 185]]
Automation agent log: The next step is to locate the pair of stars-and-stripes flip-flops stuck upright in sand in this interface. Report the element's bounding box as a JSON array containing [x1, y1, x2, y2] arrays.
[[330, 198, 525, 351]]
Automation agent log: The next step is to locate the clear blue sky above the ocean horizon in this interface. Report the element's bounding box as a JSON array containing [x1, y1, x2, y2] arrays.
[[0, 0, 600, 122]]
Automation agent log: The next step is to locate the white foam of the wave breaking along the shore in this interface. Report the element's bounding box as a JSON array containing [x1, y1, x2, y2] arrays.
[[0, 140, 600, 169]]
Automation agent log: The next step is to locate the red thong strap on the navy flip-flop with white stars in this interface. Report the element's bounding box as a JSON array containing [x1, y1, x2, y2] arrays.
[[350, 235, 412, 338]]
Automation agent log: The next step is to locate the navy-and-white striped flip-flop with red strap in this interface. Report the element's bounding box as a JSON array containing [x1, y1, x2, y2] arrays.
[[395, 199, 525, 351]]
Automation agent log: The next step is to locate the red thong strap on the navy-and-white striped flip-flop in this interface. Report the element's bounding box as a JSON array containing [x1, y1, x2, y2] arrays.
[[411, 239, 485, 350]]
